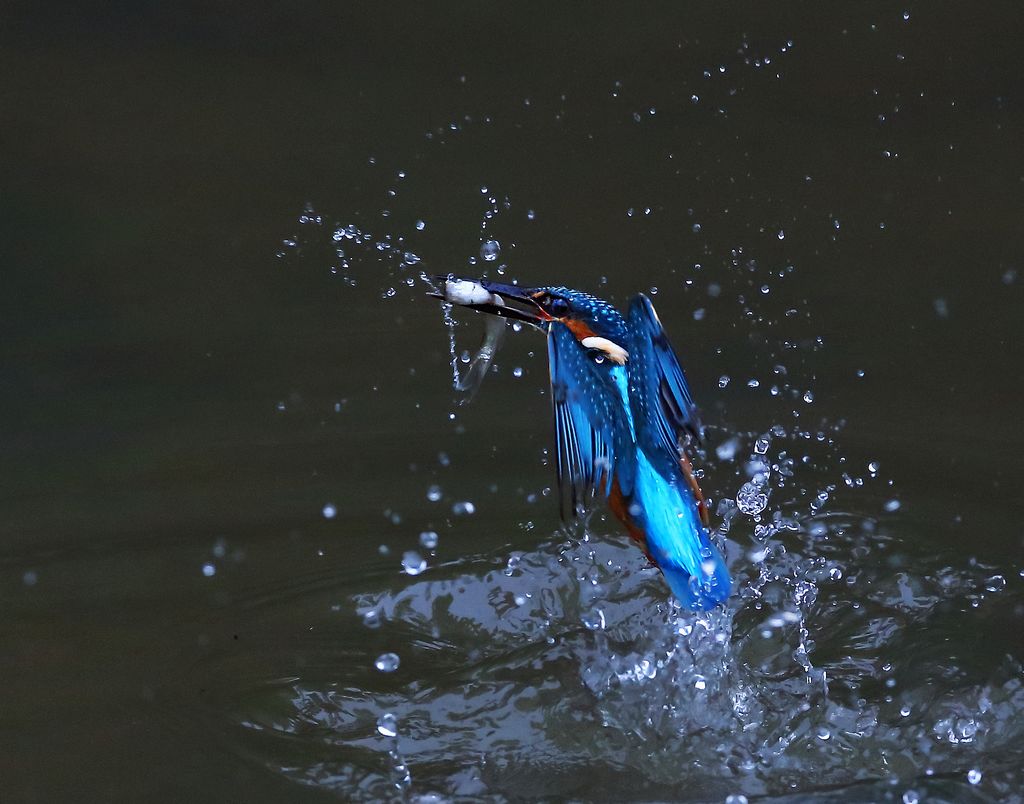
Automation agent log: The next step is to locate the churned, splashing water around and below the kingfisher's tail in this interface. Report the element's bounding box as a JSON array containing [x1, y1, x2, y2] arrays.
[[230, 417, 1024, 801]]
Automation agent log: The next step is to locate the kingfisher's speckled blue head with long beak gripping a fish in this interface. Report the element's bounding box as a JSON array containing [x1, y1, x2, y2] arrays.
[[433, 277, 630, 366]]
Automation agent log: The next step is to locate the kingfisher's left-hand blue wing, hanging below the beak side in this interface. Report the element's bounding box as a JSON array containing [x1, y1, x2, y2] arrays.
[[548, 322, 633, 519]]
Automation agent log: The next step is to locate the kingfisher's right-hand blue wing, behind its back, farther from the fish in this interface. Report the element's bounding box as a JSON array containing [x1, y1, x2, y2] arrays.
[[629, 293, 701, 455]]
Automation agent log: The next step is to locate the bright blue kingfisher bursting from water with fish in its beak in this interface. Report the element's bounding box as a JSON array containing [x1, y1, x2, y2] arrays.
[[431, 274, 731, 610]]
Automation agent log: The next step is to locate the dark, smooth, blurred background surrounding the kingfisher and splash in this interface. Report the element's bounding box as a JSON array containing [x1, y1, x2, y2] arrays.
[[0, 2, 1024, 801]]
